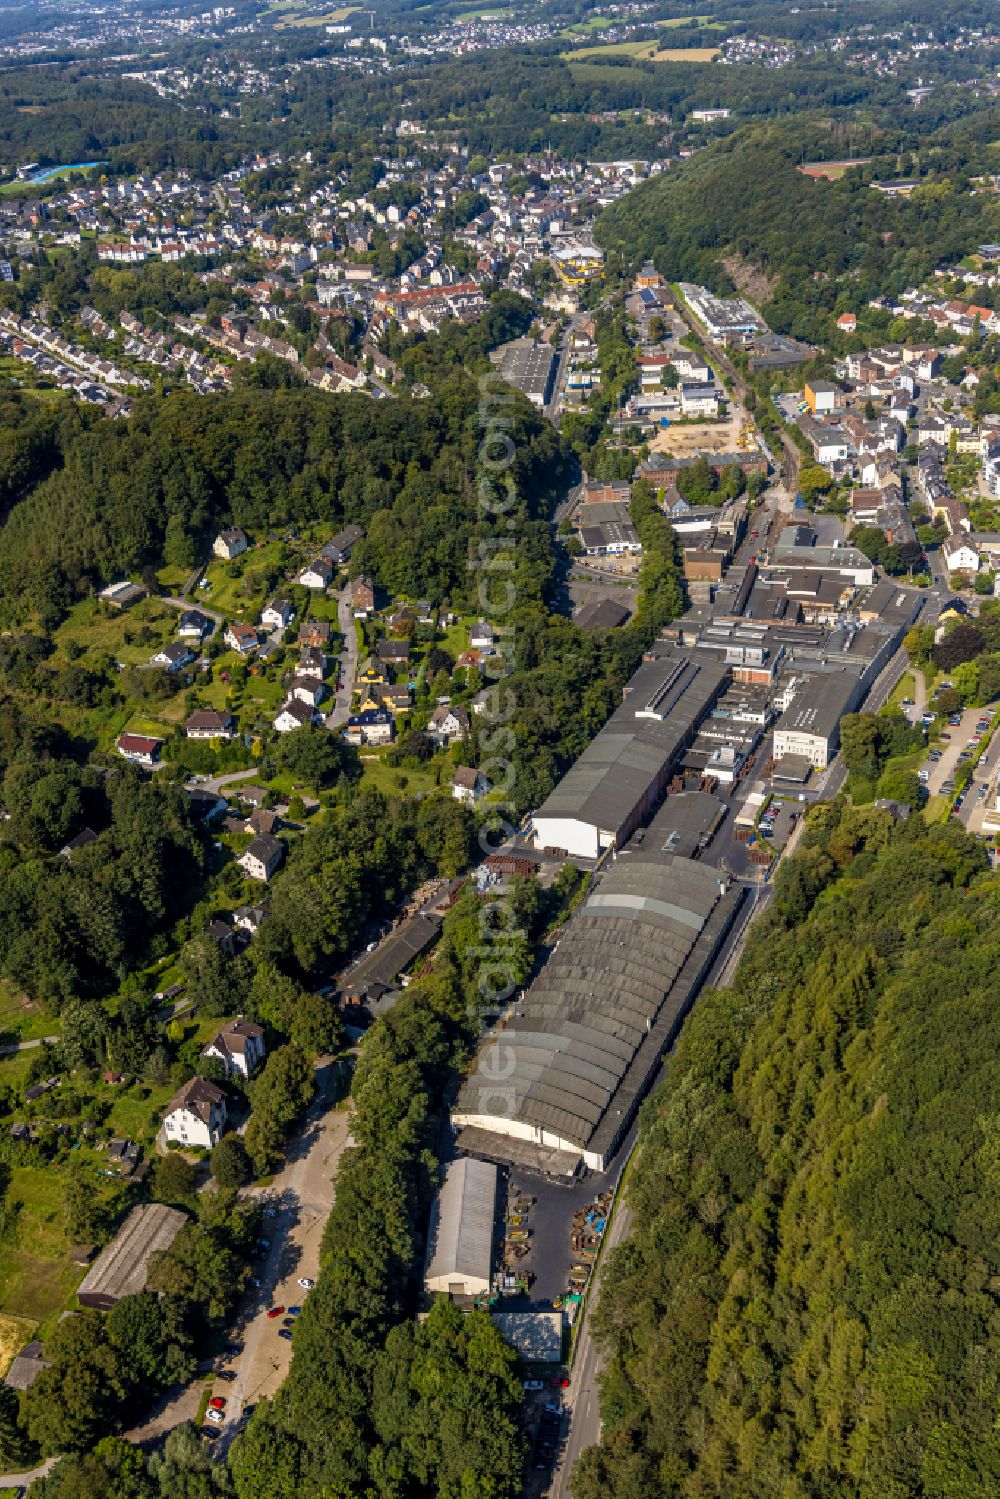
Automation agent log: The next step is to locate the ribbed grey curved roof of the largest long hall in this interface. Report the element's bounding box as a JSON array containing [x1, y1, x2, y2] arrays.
[[456, 838, 723, 1148]]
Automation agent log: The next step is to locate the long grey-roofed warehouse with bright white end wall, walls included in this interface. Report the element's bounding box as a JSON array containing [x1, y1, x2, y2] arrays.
[[534, 642, 729, 859]]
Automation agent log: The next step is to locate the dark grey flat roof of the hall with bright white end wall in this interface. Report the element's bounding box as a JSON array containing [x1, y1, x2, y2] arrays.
[[535, 649, 729, 835]]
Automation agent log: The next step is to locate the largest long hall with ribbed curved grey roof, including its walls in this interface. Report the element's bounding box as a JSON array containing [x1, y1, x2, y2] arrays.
[[453, 799, 742, 1175]]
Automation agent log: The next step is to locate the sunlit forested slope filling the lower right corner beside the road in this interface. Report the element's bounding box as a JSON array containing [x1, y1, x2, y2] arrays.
[[573, 803, 1000, 1499]]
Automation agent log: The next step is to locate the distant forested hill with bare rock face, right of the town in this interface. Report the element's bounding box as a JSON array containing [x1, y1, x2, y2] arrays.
[[597, 111, 1000, 339]]
